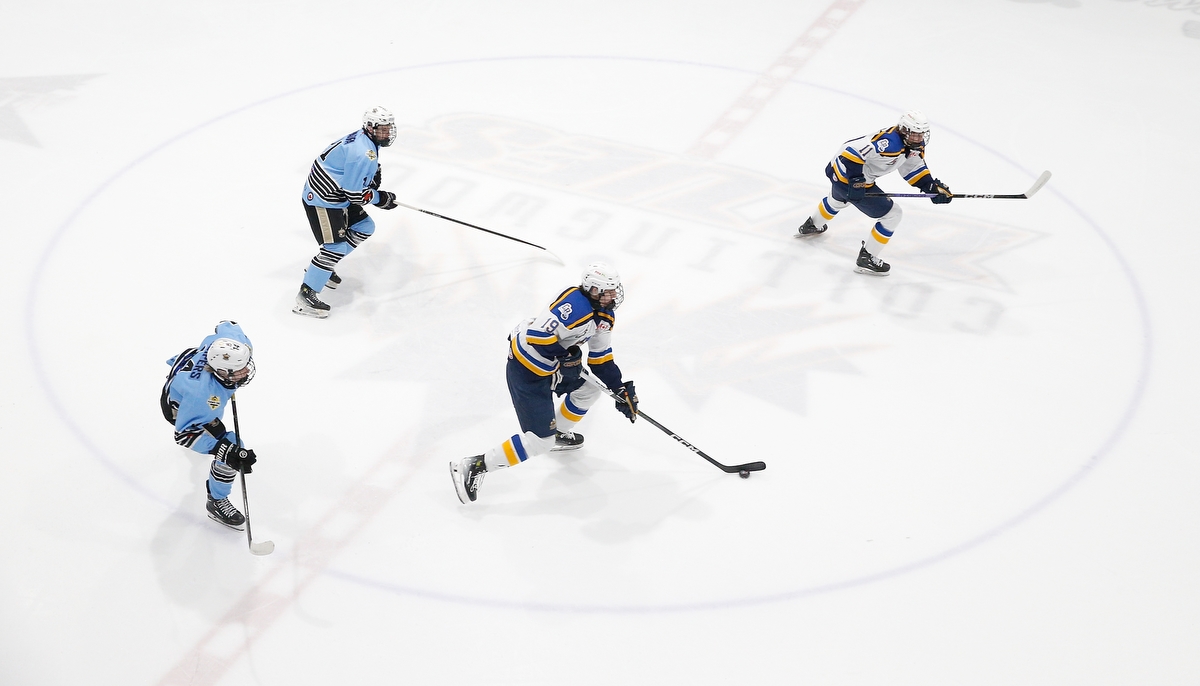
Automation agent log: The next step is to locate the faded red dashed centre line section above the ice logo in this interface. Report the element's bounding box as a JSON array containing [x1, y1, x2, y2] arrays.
[[688, 0, 866, 158]]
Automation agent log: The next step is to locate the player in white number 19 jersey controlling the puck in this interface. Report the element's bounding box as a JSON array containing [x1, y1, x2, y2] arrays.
[[450, 263, 637, 504]]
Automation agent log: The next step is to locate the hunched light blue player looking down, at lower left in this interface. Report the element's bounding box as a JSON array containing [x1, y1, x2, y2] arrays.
[[158, 321, 257, 531]]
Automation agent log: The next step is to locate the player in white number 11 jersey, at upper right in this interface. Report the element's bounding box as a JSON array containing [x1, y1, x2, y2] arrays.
[[796, 110, 953, 276]]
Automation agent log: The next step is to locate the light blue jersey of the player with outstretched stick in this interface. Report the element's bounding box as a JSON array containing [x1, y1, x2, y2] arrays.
[[304, 128, 379, 207]]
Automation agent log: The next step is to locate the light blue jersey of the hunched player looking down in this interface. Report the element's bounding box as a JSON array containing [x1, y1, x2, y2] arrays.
[[166, 321, 254, 452]]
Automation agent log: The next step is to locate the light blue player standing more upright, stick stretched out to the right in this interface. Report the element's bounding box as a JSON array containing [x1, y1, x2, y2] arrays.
[[292, 107, 397, 319]]
